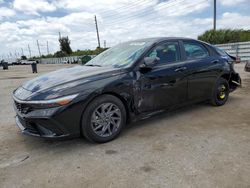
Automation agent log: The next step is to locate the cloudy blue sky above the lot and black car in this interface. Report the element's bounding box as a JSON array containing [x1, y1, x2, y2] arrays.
[[0, 0, 250, 59]]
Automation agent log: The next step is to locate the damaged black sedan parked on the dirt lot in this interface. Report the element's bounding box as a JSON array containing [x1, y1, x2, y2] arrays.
[[13, 38, 241, 142]]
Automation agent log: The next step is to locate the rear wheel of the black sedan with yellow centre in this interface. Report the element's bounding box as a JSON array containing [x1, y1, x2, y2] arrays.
[[211, 78, 230, 106]]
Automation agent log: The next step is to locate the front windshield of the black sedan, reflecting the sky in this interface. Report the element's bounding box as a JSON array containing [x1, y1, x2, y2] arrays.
[[85, 41, 150, 68]]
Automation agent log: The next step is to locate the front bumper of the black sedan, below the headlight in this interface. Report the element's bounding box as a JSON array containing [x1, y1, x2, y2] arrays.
[[14, 98, 82, 139]]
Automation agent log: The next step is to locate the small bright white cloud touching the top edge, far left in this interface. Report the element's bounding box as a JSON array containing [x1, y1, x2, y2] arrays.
[[13, 0, 56, 15]]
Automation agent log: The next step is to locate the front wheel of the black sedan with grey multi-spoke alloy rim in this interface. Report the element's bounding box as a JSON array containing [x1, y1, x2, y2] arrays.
[[81, 94, 126, 143]]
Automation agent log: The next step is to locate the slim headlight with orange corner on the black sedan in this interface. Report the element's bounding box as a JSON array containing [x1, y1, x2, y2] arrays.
[[15, 94, 78, 108]]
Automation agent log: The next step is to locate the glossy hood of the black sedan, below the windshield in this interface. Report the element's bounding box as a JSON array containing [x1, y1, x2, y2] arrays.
[[22, 66, 121, 93]]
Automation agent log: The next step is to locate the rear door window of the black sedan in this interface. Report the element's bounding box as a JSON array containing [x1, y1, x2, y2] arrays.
[[183, 41, 209, 60]]
